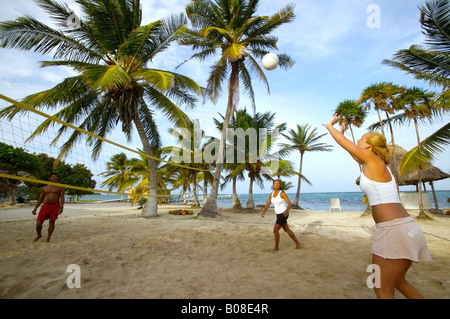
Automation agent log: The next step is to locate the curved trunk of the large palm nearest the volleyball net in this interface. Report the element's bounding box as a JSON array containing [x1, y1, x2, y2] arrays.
[[134, 113, 158, 218]]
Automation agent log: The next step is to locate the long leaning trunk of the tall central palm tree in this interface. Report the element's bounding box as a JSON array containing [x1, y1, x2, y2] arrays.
[[200, 63, 239, 217]]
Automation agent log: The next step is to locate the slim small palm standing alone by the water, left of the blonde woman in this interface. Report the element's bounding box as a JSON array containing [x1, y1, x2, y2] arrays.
[[281, 124, 333, 207]]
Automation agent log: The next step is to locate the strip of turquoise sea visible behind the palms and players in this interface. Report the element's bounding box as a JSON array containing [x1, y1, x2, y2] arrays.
[[81, 191, 450, 212]]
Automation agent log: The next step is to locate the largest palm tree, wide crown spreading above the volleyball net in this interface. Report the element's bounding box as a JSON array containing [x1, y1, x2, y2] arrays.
[[0, 0, 203, 217]]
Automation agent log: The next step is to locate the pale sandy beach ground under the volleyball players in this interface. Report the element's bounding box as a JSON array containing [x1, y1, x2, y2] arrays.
[[0, 202, 450, 299]]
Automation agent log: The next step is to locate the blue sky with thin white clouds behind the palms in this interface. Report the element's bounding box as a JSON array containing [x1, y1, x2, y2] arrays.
[[0, 0, 450, 193]]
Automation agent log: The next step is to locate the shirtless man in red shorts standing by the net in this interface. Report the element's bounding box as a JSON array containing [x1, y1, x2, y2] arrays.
[[33, 173, 64, 241]]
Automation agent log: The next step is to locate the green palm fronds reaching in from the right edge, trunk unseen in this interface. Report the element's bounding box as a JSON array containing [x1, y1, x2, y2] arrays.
[[383, 0, 450, 170]]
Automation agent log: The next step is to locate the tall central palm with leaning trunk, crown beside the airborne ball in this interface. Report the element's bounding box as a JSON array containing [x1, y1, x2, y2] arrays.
[[180, 0, 294, 217]]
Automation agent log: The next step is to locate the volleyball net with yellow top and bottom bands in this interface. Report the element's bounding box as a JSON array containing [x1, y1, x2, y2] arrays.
[[0, 94, 201, 202]]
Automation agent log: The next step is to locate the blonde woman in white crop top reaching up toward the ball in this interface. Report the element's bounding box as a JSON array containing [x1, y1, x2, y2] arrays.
[[324, 115, 431, 299]]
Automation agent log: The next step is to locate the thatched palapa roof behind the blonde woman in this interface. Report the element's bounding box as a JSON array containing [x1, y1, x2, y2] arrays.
[[388, 144, 450, 186]]
